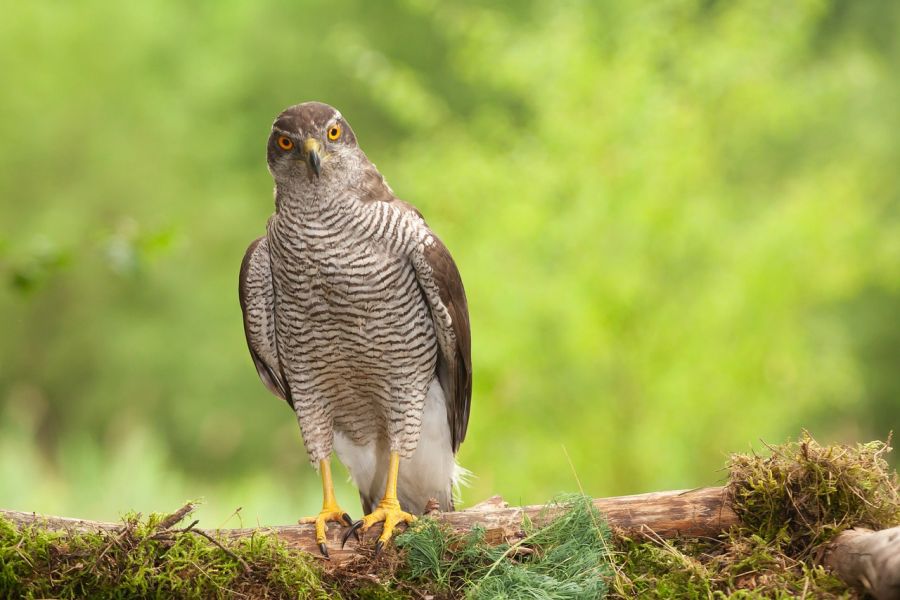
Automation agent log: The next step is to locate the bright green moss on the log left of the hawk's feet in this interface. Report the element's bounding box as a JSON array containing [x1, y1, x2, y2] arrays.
[[0, 508, 333, 598]]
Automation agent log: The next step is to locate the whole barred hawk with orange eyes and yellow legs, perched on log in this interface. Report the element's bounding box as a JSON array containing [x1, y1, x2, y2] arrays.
[[239, 102, 472, 556]]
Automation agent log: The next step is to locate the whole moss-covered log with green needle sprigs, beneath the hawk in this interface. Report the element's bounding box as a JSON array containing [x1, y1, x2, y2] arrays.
[[0, 435, 900, 600]]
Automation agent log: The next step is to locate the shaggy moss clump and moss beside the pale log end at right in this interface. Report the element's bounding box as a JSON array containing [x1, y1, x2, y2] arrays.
[[613, 433, 900, 599]]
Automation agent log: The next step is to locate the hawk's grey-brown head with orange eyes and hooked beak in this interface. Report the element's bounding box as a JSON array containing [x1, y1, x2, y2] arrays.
[[268, 102, 365, 187]]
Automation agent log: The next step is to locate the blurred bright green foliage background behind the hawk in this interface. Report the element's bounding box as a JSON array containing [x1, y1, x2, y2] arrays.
[[0, 0, 900, 526]]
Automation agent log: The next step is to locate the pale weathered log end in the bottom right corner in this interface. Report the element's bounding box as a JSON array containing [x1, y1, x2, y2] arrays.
[[824, 527, 900, 600]]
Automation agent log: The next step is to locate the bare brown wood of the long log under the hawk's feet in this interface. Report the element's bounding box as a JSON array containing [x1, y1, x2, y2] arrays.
[[0, 487, 738, 563]]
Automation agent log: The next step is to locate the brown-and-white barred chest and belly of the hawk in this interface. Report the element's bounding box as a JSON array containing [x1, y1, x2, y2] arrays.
[[269, 202, 437, 439]]
